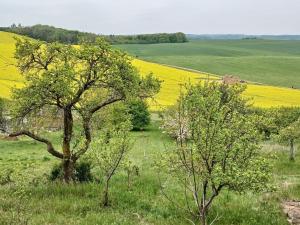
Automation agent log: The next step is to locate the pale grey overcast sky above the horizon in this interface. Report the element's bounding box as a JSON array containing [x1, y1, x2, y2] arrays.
[[0, 0, 300, 34]]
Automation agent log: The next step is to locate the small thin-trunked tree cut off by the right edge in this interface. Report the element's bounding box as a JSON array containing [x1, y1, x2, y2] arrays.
[[278, 120, 300, 161]]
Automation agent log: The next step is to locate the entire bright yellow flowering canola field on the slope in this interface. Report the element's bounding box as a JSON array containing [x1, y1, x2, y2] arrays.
[[0, 32, 300, 110]]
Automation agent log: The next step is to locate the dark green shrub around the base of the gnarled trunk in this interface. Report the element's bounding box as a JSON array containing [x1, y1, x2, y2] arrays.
[[49, 161, 93, 183]]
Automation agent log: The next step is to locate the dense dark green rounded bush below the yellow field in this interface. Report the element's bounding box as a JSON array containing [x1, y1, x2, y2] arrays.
[[126, 100, 150, 130]]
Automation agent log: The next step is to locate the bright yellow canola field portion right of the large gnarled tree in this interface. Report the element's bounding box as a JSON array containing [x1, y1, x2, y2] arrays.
[[133, 59, 300, 109]]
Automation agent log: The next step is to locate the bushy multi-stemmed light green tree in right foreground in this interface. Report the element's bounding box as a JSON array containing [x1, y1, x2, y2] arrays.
[[163, 82, 270, 225]]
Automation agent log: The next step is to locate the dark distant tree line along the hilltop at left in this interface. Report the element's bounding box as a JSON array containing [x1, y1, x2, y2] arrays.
[[0, 24, 188, 44]]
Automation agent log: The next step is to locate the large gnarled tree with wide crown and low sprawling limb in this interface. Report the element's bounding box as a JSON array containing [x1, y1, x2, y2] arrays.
[[10, 39, 160, 182]]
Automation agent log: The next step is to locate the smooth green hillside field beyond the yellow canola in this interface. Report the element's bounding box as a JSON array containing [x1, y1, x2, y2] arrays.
[[118, 40, 300, 88]]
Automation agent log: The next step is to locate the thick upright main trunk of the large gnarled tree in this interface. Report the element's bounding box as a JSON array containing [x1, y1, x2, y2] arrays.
[[62, 108, 75, 183]]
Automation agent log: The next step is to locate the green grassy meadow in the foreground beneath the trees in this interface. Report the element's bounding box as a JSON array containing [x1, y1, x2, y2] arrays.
[[0, 118, 300, 225]]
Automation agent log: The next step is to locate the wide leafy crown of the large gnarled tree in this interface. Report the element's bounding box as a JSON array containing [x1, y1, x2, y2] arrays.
[[14, 39, 160, 118]]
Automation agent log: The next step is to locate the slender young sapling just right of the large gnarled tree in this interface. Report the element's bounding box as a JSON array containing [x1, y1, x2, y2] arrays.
[[88, 120, 131, 206]]
